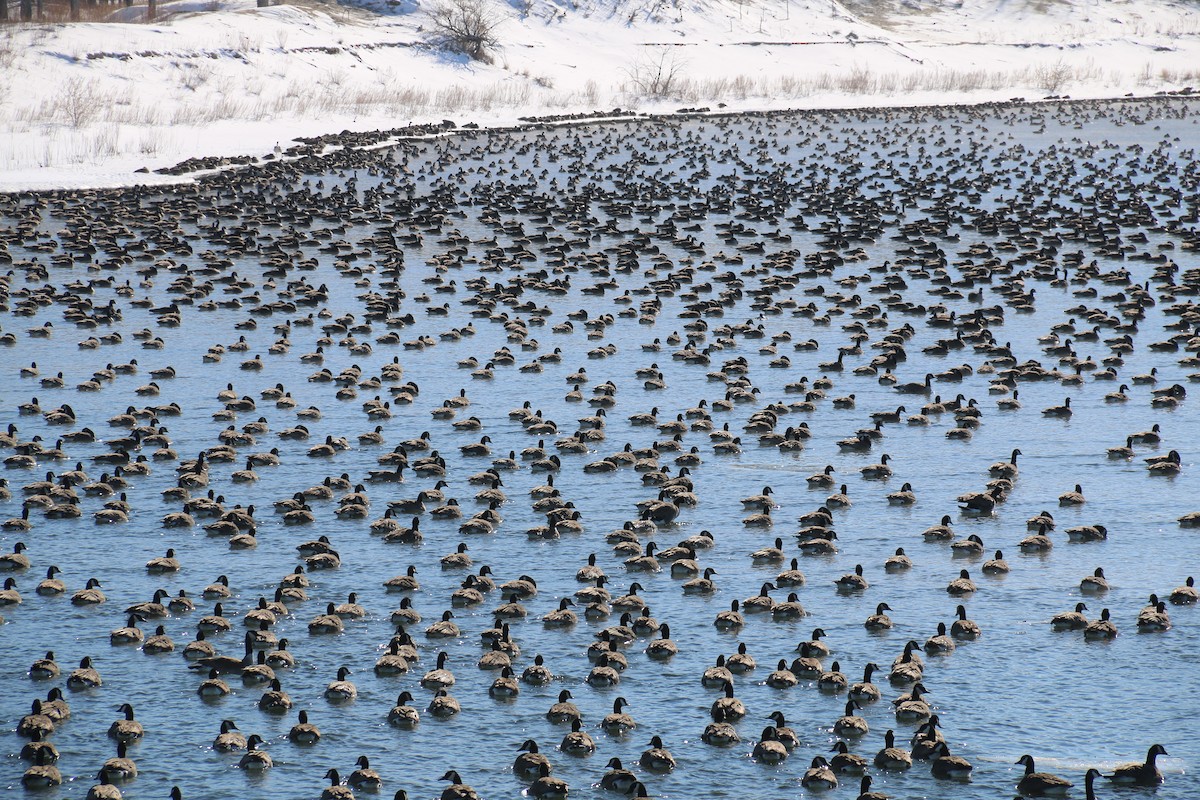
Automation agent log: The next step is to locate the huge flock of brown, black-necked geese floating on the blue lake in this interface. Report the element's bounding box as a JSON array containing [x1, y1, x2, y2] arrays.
[[0, 100, 1200, 800]]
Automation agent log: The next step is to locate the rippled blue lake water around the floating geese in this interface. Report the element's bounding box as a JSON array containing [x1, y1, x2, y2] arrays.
[[0, 100, 1200, 799]]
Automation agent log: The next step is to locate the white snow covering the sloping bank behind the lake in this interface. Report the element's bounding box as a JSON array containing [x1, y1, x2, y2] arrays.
[[0, 0, 1200, 191]]
